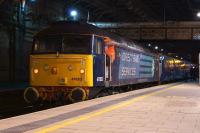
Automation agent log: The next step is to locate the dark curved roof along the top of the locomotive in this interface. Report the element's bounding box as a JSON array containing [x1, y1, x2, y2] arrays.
[[35, 21, 155, 53]]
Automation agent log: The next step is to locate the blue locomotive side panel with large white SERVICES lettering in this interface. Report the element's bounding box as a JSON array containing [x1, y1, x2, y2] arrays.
[[111, 47, 158, 86]]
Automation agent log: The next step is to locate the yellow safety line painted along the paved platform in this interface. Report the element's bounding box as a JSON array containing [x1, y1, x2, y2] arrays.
[[35, 84, 180, 133]]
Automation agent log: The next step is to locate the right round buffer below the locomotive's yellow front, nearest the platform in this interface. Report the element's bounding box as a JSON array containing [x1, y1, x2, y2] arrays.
[[68, 87, 87, 103]]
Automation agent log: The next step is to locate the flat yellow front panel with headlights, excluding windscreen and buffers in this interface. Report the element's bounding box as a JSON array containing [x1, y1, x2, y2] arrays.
[[30, 54, 93, 87]]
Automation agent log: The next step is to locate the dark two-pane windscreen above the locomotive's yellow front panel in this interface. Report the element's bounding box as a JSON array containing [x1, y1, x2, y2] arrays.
[[33, 35, 92, 54]]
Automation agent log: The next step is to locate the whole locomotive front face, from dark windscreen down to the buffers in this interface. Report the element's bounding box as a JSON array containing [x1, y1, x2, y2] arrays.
[[24, 28, 94, 103]]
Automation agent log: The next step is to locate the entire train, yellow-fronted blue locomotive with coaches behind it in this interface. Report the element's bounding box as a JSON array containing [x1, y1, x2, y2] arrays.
[[24, 22, 190, 103]]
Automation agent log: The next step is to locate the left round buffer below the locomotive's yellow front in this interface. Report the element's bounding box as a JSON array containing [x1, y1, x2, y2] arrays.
[[24, 87, 39, 103]]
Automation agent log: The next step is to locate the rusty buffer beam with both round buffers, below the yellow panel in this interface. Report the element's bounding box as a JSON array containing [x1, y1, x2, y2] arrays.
[[24, 86, 91, 104]]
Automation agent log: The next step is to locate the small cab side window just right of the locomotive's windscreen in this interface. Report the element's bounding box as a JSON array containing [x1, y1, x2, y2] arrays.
[[94, 37, 103, 55]]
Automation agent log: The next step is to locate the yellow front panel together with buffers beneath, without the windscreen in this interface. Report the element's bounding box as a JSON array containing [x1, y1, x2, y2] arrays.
[[24, 54, 93, 103]]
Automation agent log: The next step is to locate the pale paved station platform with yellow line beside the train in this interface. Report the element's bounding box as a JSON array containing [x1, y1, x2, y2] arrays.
[[0, 83, 200, 133]]
